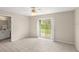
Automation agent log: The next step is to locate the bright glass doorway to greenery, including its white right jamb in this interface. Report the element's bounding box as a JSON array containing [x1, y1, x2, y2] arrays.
[[39, 19, 54, 39]]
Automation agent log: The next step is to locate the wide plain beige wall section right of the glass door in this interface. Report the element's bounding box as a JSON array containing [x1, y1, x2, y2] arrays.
[[55, 11, 75, 44]]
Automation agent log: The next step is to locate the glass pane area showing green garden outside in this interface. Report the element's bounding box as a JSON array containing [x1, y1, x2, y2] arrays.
[[39, 19, 51, 38]]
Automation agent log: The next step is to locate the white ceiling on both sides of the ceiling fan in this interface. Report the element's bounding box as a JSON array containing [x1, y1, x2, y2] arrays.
[[0, 7, 76, 16]]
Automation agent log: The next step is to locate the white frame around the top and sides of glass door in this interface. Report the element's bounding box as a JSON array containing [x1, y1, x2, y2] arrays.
[[37, 17, 55, 40]]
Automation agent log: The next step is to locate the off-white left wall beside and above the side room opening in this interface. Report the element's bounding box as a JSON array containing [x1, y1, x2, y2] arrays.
[[0, 11, 29, 41]]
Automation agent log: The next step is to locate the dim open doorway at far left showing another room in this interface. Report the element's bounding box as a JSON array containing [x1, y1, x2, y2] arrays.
[[0, 16, 11, 40]]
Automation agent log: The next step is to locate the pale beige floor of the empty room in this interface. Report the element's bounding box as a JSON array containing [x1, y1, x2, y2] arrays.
[[0, 38, 76, 52]]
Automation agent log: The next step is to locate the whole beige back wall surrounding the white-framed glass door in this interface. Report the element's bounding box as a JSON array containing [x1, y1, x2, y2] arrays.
[[30, 11, 75, 44]]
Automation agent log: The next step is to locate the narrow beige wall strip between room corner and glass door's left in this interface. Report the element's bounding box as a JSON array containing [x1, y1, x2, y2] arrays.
[[29, 16, 37, 37]]
